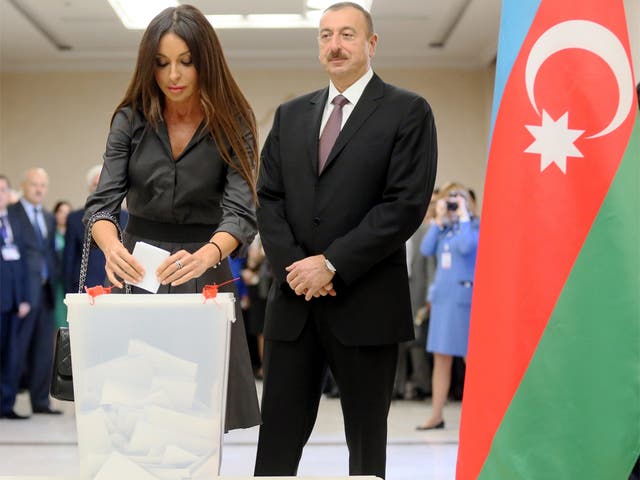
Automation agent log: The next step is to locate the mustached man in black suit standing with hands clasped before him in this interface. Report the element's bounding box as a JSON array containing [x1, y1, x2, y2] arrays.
[[255, 2, 436, 477]]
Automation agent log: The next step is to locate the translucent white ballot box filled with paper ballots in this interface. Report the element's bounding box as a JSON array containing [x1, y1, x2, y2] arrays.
[[65, 293, 235, 480]]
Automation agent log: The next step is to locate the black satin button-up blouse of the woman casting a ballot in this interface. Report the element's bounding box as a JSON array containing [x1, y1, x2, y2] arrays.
[[84, 107, 257, 246]]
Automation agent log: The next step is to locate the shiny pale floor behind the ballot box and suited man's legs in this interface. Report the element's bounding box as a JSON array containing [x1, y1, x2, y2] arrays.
[[0, 395, 460, 480]]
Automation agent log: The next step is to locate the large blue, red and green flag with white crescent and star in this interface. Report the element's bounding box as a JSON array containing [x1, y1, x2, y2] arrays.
[[457, 0, 640, 480]]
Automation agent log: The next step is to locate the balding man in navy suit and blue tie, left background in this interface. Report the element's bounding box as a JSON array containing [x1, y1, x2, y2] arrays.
[[8, 168, 61, 414]]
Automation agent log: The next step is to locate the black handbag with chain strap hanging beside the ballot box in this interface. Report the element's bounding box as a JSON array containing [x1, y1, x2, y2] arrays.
[[49, 212, 131, 402]]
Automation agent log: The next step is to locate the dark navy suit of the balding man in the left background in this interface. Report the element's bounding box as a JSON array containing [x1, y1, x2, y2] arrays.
[[8, 202, 59, 409]]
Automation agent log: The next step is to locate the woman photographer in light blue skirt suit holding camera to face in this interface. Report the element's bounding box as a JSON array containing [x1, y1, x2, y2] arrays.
[[416, 185, 480, 430]]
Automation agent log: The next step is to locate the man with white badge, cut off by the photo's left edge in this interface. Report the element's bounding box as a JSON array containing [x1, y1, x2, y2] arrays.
[[0, 174, 31, 420]]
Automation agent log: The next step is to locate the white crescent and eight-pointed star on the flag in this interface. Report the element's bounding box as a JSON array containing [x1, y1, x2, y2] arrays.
[[524, 20, 634, 175]]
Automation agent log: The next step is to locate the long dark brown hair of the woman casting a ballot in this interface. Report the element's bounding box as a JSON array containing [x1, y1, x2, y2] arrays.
[[111, 5, 259, 201]]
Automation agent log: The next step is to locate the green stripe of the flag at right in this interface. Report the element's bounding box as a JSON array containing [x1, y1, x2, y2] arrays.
[[479, 115, 640, 480]]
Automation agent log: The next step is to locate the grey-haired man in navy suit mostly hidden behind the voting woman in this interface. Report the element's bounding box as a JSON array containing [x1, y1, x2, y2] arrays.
[[62, 165, 129, 293]]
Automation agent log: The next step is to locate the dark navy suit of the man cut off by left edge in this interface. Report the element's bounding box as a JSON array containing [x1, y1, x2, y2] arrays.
[[0, 211, 30, 415]]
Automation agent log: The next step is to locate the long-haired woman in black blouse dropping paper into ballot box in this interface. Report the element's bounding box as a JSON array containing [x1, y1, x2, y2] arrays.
[[84, 5, 260, 430]]
